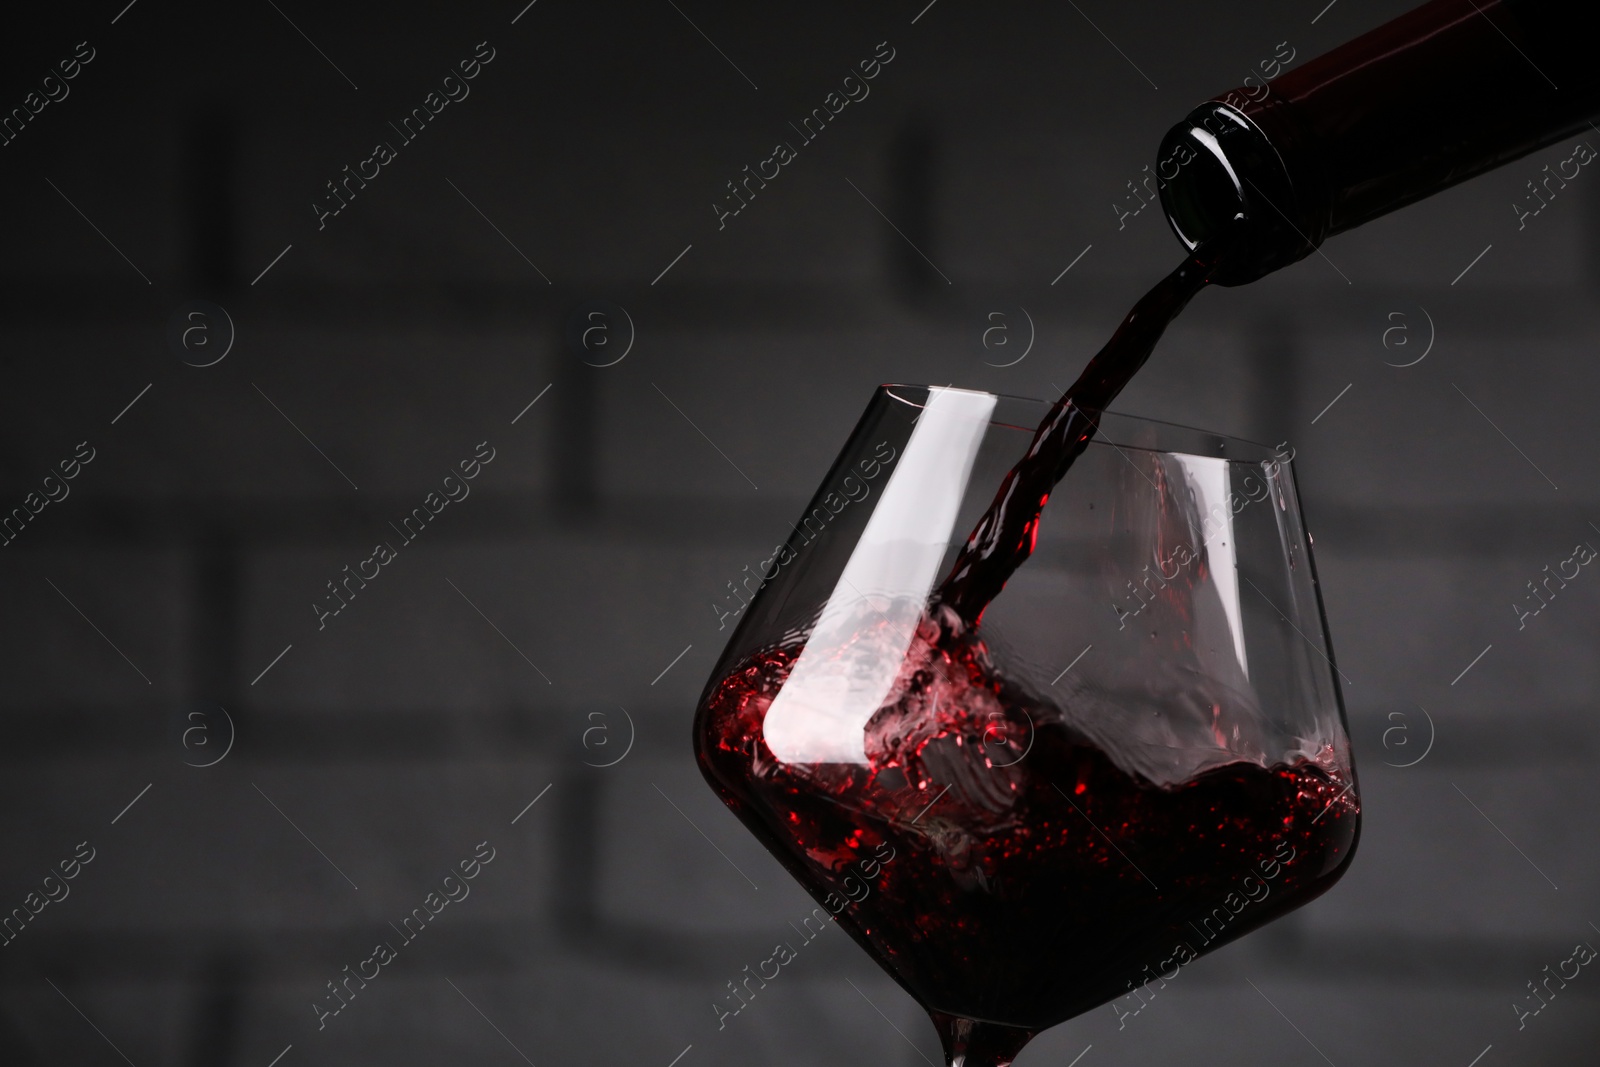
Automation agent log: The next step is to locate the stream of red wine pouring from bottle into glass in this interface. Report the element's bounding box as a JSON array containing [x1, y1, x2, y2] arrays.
[[931, 233, 1243, 629]]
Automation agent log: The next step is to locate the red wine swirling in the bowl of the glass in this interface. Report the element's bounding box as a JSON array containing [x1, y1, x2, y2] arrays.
[[698, 624, 1358, 1036]]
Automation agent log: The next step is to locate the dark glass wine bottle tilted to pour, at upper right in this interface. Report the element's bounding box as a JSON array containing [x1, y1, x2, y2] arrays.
[[1157, 0, 1600, 285]]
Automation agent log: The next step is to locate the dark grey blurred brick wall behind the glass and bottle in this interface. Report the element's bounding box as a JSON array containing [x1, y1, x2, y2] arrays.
[[0, 0, 1600, 1067]]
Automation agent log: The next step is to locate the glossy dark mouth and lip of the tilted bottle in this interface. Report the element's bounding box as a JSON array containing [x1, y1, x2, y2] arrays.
[[1157, 101, 1315, 285]]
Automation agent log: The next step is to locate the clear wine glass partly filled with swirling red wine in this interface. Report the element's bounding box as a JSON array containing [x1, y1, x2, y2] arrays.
[[694, 386, 1360, 1067]]
